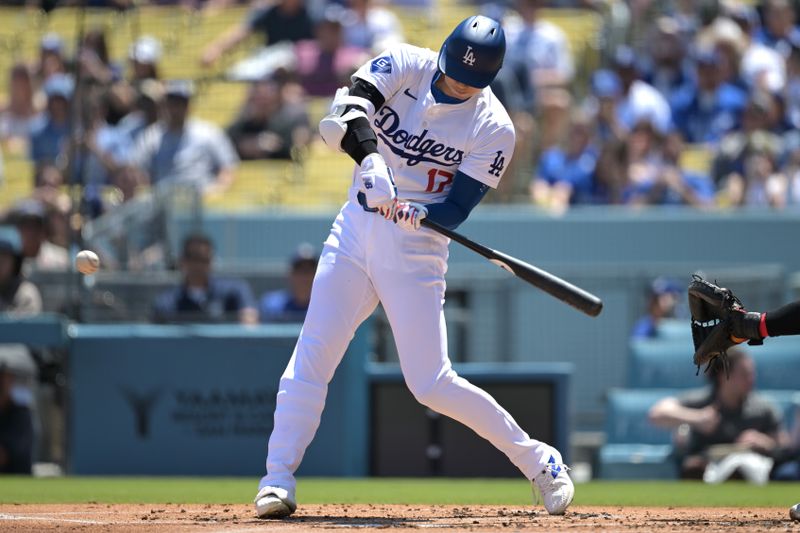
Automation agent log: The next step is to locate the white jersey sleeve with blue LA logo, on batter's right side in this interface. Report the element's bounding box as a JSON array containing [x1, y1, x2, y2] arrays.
[[458, 123, 515, 189]]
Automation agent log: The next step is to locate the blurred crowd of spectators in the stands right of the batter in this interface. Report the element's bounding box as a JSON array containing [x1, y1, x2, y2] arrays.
[[501, 0, 800, 210]]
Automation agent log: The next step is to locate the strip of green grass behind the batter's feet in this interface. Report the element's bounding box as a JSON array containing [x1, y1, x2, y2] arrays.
[[0, 477, 800, 507]]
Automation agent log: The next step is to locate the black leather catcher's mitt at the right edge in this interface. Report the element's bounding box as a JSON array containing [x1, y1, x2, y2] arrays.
[[689, 274, 761, 371]]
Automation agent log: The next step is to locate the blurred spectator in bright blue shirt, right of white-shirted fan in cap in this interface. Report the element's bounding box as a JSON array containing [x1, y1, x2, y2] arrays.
[[672, 47, 747, 143]]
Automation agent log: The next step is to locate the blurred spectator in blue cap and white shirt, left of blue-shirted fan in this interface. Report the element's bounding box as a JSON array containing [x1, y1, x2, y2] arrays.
[[614, 46, 672, 135]]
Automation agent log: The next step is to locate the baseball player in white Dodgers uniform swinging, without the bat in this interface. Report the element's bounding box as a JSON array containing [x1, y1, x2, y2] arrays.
[[255, 16, 575, 518]]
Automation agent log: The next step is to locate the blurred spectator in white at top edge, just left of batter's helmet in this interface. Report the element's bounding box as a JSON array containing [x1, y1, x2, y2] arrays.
[[341, 0, 403, 54]]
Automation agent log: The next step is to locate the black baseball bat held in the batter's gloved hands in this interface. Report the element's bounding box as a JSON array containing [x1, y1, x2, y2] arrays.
[[421, 218, 603, 316]]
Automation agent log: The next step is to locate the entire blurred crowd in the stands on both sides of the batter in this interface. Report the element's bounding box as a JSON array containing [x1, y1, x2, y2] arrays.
[[0, 0, 800, 221]]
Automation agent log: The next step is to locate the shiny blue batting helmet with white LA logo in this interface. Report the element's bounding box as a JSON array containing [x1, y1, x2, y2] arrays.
[[439, 15, 506, 89]]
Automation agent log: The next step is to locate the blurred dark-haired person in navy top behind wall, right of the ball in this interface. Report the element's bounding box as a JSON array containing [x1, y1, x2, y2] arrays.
[[153, 234, 258, 324]]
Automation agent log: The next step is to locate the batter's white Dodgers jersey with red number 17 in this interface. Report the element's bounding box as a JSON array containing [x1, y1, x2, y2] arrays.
[[353, 44, 514, 203]]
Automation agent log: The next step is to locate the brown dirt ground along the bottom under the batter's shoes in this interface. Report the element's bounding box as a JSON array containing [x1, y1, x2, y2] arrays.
[[0, 504, 800, 533]]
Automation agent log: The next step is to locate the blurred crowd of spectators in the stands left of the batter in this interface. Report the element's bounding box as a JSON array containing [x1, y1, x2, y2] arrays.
[[0, 0, 402, 229]]
